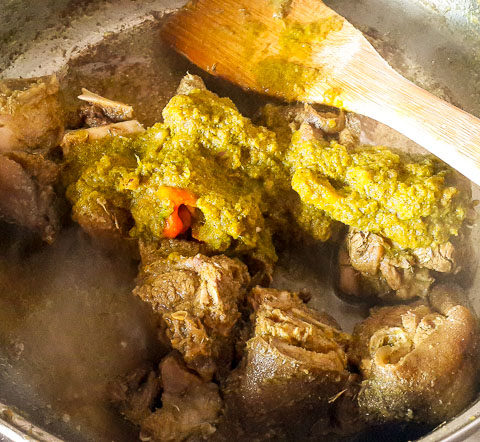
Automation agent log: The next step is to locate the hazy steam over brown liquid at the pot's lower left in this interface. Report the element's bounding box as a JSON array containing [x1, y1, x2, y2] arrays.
[[0, 228, 163, 440]]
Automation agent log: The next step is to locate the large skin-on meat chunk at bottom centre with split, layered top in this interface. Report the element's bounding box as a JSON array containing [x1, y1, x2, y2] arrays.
[[224, 288, 358, 440]]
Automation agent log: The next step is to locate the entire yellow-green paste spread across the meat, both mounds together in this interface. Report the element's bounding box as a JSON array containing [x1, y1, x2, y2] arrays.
[[64, 84, 467, 261]]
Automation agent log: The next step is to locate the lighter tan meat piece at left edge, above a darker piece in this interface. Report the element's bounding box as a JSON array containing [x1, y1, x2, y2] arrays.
[[0, 76, 64, 153]]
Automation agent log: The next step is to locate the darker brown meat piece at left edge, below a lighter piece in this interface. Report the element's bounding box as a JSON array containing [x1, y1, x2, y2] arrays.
[[0, 151, 60, 243]]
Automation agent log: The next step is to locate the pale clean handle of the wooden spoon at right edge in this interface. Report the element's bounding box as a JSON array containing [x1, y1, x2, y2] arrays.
[[349, 64, 480, 185]]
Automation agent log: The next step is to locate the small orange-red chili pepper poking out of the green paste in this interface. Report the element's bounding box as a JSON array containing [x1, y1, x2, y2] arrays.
[[157, 186, 197, 238]]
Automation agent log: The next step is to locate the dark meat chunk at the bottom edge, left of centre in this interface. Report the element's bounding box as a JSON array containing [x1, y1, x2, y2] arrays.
[[111, 353, 223, 442]]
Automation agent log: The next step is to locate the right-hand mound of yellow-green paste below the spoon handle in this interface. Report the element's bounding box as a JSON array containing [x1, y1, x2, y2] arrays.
[[287, 133, 468, 249]]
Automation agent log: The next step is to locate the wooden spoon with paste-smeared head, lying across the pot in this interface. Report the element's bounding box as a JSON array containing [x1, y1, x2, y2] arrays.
[[162, 0, 480, 185]]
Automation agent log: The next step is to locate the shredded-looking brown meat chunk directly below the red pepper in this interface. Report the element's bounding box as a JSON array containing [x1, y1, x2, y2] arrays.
[[134, 241, 250, 379]]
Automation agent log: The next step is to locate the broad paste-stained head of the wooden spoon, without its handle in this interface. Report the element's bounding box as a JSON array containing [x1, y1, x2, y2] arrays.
[[162, 0, 379, 108]]
